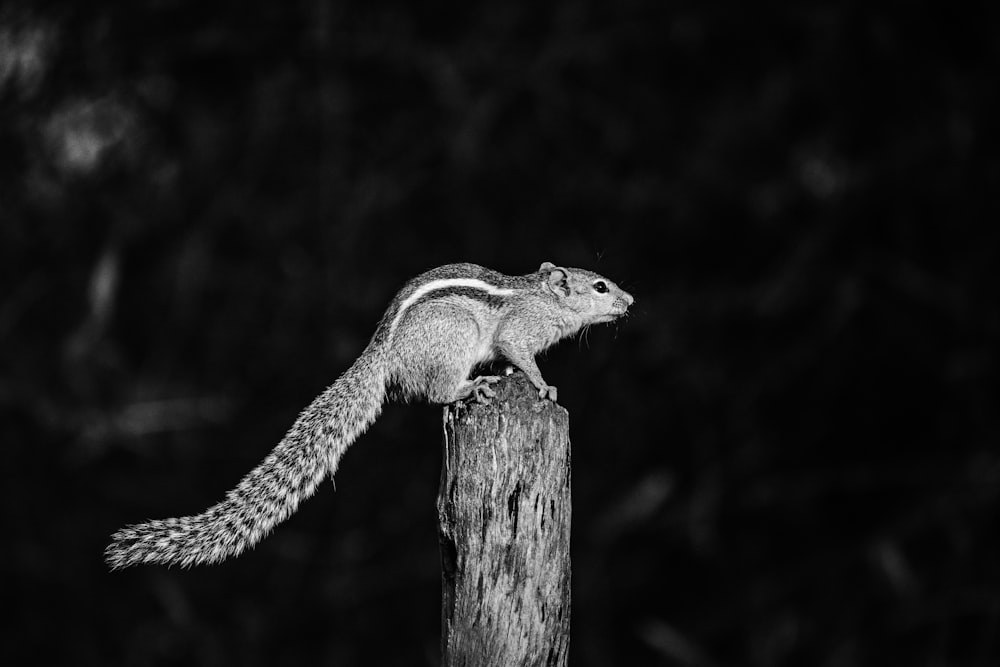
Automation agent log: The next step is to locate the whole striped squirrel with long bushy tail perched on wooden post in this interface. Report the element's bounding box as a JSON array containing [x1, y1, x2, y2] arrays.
[[105, 262, 634, 570]]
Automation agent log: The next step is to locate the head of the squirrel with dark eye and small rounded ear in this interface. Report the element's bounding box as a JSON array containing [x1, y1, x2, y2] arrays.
[[538, 262, 635, 325]]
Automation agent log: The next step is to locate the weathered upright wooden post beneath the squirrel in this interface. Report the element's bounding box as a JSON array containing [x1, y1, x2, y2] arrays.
[[437, 373, 571, 667]]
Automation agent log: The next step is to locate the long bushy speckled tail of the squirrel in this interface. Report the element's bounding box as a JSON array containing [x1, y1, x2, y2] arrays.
[[104, 343, 388, 570]]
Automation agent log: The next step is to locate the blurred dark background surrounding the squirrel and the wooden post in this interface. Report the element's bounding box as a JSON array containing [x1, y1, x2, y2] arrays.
[[0, 0, 1000, 667]]
